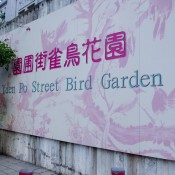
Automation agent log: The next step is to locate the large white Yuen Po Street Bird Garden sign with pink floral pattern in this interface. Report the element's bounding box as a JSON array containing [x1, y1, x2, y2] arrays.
[[0, 0, 175, 160]]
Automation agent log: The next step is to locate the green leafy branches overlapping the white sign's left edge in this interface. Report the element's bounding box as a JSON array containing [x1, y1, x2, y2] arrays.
[[0, 41, 16, 70]]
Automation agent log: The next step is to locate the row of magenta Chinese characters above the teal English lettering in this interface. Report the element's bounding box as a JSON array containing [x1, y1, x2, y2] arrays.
[[13, 31, 126, 75]]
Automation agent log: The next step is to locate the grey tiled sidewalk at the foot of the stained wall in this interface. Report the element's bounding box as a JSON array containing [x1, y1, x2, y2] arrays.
[[0, 155, 56, 175]]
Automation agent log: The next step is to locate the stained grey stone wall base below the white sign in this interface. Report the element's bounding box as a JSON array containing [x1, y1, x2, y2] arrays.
[[0, 130, 175, 175]]
